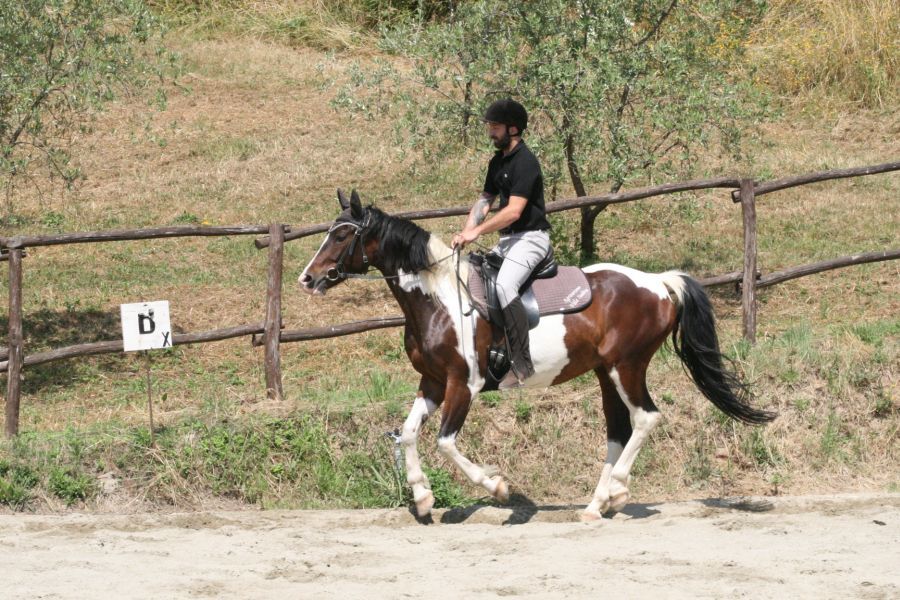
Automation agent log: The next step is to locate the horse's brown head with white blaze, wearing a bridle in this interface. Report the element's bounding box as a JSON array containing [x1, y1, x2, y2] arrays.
[[299, 190, 370, 294]]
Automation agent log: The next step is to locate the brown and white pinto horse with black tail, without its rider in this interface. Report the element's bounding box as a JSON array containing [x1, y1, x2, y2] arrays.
[[299, 191, 775, 520]]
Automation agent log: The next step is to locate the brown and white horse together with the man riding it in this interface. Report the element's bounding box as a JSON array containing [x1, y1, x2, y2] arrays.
[[299, 100, 775, 521]]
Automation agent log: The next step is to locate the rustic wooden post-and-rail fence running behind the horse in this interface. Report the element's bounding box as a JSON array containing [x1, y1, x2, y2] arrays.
[[0, 162, 900, 436]]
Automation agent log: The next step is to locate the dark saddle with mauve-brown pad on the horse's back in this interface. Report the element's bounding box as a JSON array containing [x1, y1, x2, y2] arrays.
[[468, 248, 592, 391]]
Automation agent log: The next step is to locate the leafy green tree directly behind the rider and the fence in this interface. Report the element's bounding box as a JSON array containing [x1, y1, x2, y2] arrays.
[[337, 0, 764, 261]]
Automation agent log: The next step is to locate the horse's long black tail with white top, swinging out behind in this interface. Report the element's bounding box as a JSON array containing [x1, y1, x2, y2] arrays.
[[660, 271, 775, 424]]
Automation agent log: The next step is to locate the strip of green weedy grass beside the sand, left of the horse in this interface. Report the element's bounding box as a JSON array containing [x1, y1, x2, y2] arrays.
[[0, 413, 406, 508]]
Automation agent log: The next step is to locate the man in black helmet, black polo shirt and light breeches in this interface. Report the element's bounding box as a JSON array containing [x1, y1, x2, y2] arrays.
[[452, 98, 550, 382]]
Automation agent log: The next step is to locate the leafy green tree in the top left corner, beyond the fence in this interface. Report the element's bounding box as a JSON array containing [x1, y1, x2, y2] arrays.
[[0, 0, 169, 216]]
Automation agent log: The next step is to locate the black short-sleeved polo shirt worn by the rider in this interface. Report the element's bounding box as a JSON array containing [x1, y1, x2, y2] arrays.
[[484, 141, 550, 233]]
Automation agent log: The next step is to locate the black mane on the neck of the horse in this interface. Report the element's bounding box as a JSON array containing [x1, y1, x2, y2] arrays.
[[366, 205, 431, 273]]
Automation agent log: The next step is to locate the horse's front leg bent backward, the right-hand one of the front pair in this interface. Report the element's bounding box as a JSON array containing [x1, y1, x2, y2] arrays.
[[438, 381, 509, 503]]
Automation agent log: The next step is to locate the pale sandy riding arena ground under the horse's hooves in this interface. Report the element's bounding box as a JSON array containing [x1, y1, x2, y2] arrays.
[[0, 494, 900, 599]]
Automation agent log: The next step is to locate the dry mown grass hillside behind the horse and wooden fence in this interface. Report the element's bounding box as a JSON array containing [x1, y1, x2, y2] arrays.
[[0, 4, 900, 506]]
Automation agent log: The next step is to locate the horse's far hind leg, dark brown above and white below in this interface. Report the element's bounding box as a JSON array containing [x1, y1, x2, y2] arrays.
[[582, 367, 632, 521]]
